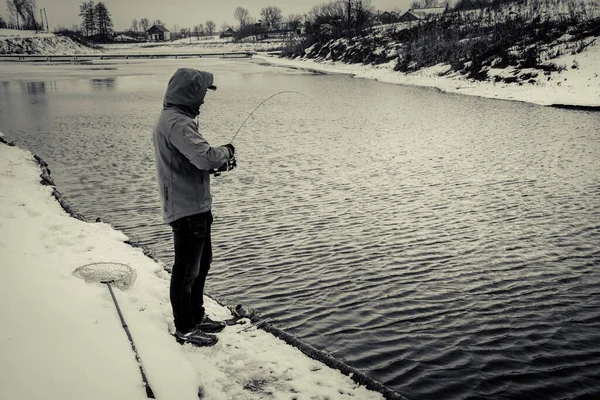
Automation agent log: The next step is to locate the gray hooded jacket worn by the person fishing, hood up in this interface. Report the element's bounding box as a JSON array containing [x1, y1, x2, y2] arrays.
[[153, 68, 229, 223]]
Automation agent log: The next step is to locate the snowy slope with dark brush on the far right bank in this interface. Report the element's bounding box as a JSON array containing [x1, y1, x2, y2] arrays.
[[278, 0, 600, 110]]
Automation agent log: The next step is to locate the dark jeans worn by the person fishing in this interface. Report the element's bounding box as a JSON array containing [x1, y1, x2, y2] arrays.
[[170, 211, 213, 333]]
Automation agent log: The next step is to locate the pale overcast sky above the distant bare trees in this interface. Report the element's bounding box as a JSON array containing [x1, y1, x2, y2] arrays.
[[25, 0, 412, 30]]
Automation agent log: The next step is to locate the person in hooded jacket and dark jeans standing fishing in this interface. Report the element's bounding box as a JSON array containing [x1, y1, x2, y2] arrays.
[[153, 68, 235, 346]]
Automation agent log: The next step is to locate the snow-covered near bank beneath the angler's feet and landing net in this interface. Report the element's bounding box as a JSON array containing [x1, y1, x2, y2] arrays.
[[0, 140, 383, 400]]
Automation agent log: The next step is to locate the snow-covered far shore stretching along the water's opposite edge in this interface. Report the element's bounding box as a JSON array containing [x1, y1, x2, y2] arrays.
[[0, 28, 600, 111]]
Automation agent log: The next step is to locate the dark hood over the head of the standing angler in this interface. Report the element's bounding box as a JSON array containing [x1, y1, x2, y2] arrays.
[[163, 68, 213, 118]]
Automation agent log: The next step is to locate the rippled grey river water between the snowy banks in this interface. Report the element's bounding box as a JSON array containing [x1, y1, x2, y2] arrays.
[[0, 59, 600, 399]]
